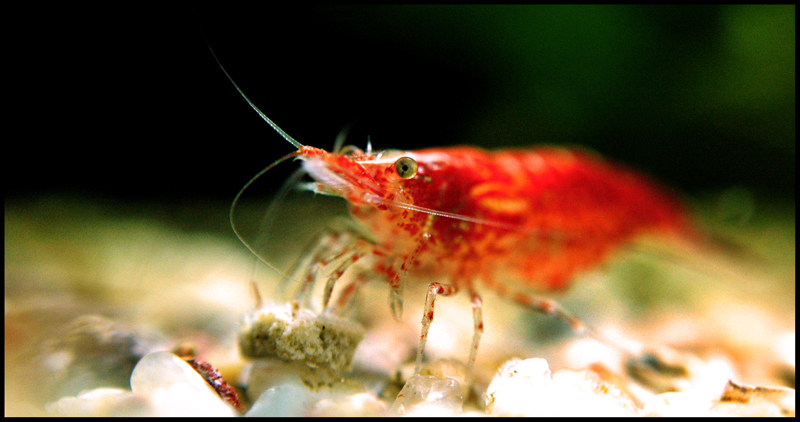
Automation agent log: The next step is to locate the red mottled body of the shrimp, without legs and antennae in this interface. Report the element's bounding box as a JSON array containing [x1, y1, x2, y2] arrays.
[[301, 147, 691, 297]]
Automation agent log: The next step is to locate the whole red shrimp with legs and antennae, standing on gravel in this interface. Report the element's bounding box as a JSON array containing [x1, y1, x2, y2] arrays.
[[212, 47, 697, 373]]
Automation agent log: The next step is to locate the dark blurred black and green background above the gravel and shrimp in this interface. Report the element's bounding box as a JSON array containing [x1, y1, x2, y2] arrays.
[[5, 3, 795, 201]]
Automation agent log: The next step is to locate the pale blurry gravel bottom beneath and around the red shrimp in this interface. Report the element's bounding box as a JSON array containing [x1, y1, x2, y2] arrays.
[[4, 195, 796, 416]]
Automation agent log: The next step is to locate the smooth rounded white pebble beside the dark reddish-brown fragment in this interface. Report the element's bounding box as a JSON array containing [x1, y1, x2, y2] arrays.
[[131, 352, 236, 416]]
